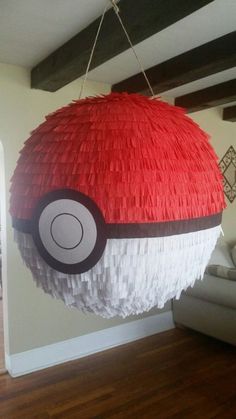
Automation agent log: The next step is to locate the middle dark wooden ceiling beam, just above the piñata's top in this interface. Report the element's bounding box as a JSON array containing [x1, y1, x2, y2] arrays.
[[112, 31, 236, 94]]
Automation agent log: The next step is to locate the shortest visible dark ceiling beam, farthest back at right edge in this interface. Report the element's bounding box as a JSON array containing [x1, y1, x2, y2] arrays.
[[175, 79, 236, 112]]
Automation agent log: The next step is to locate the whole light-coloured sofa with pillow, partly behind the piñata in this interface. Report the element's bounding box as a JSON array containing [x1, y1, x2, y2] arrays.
[[173, 239, 236, 345]]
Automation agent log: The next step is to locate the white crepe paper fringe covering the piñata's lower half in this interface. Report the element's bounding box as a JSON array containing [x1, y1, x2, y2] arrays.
[[15, 226, 221, 318]]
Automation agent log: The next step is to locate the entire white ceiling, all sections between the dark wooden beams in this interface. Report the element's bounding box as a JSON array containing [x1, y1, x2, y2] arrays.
[[0, 0, 236, 96]]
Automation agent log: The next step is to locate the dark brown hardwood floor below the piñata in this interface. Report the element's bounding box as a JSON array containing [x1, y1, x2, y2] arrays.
[[0, 329, 236, 419]]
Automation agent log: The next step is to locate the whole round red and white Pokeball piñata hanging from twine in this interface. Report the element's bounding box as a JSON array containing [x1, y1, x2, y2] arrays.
[[10, 93, 225, 317]]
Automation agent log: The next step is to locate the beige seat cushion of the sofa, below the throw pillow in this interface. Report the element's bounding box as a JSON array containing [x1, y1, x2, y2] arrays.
[[186, 274, 236, 309]]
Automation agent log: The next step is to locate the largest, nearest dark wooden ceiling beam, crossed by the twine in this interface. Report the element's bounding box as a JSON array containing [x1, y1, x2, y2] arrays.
[[31, 0, 216, 92]]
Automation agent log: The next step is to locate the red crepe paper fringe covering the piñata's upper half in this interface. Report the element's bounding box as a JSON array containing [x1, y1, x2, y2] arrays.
[[10, 93, 225, 223]]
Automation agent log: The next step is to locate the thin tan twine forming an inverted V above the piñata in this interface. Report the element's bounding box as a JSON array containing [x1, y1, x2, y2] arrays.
[[79, 0, 155, 99]]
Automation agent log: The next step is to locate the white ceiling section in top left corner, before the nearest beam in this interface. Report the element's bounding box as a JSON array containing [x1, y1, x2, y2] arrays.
[[0, 0, 107, 67]]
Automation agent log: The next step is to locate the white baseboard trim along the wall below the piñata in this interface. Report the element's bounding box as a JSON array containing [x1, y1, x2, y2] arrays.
[[6, 311, 175, 377]]
